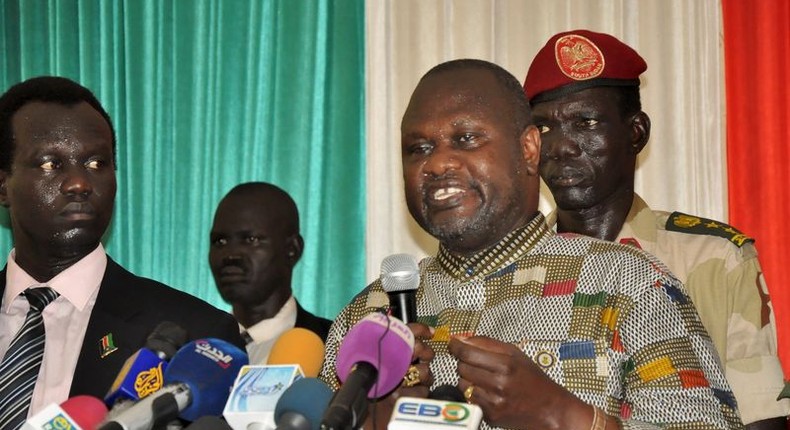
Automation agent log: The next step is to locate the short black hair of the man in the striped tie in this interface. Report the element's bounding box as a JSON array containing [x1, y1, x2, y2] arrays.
[[0, 76, 117, 171]]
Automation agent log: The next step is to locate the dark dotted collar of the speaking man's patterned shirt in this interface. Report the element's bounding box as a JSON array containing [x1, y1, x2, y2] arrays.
[[436, 212, 550, 280]]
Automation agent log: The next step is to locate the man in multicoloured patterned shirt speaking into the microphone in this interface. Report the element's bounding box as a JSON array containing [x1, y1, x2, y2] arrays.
[[321, 60, 741, 430]]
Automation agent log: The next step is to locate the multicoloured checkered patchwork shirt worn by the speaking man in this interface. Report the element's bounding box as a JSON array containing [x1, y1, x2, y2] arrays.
[[321, 215, 742, 429]]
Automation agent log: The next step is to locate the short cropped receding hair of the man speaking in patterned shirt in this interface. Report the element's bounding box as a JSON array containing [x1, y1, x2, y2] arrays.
[[422, 58, 532, 134]]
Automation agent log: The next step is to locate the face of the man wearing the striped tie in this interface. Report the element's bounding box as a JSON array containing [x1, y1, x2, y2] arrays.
[[0, 102, 116, 282]]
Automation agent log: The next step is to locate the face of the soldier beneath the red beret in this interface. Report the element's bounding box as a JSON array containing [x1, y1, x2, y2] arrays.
[[532, 87, 650, 240]]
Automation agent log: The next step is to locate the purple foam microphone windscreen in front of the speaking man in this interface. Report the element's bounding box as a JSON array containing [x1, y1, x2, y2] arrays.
[[336, 313, 414, 399]]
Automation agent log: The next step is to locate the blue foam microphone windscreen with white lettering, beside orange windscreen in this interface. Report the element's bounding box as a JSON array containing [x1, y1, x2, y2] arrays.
[[165, 338, 249, 421]]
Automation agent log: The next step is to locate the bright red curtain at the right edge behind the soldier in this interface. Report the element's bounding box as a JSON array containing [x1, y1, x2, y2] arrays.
[[721, 0, 790, 380]]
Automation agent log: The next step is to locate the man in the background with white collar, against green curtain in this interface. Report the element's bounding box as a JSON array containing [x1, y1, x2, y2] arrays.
[[209, 182, 332, 363]]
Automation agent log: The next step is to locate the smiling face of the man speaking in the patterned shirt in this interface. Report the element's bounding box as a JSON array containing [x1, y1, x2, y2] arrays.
[[401, 69, 540, 255]]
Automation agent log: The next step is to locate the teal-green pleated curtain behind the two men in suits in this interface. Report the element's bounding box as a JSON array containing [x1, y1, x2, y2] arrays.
[[0, 0, 365, 318]]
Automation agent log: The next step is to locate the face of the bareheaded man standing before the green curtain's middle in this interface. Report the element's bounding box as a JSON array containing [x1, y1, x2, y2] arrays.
[[209, 194, 303, 327]]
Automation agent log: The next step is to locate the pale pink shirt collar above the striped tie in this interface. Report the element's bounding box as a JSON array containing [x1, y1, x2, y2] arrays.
[[3, 244, 107, 311]]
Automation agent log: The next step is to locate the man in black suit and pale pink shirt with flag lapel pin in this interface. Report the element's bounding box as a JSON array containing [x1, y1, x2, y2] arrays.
[[0, 77, 243, 424]]
